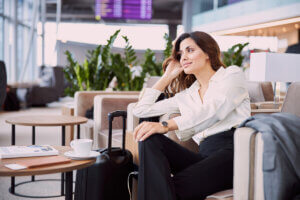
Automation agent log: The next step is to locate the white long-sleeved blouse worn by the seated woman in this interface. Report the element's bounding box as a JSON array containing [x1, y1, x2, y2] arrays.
[[133, 66, 251, 144]]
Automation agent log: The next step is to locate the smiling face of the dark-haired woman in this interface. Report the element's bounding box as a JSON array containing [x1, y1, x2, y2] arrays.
[[178, 38, 209, 74]]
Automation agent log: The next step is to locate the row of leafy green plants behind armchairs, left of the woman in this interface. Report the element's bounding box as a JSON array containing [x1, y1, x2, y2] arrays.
[[64, 30, 172, 96]]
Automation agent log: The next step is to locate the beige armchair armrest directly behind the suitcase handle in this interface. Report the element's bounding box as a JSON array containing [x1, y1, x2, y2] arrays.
[[93, 93, 138, 148]]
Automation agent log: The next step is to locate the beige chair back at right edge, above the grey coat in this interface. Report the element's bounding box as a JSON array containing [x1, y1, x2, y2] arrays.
[[281, 82, 300, 117]]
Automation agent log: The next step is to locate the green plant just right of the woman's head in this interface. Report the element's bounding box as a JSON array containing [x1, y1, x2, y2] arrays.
[[223, 42, 249, 67]]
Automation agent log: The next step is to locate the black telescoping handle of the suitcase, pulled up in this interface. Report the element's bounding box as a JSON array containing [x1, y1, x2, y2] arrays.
[[108, 110, 127, 153]]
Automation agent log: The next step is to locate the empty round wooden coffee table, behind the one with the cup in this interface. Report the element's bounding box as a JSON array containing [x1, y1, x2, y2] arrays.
[[5, 115, 88, 195]]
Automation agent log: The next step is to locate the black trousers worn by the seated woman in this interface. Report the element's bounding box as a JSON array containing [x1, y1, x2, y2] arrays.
[[138, 129, 235, 200]]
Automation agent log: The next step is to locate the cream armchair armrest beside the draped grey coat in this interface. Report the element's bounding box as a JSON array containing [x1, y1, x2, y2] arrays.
[[233, 127, 264, 200]]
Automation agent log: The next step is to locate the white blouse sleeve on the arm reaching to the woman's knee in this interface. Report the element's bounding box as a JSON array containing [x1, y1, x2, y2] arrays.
[[173, 76, 248, 140]]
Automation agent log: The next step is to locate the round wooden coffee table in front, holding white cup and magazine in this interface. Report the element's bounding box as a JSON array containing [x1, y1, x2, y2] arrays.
[[0, 146, 96, 200]]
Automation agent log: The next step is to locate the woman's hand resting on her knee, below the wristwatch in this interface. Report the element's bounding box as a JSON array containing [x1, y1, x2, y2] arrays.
[[133, 122, 168, 141]]
